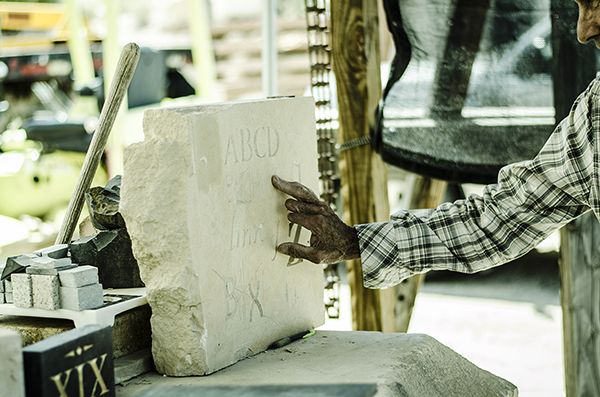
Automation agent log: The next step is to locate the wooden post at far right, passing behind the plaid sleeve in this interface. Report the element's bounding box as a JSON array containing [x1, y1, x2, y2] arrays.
[[550, 0, 600, 397]]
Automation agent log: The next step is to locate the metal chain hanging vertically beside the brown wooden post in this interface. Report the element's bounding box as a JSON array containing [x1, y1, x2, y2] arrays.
[[305, 0, 340, 318]]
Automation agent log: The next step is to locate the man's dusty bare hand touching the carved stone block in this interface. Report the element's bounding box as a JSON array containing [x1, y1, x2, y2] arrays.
[[271, 175, 360, 264]]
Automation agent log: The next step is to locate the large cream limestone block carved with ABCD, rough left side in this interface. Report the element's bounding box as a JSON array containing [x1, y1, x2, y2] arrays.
[[120, 97, 325, 376]]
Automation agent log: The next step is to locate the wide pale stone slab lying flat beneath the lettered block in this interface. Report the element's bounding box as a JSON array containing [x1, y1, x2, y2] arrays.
[[116, 331, 516, 397]]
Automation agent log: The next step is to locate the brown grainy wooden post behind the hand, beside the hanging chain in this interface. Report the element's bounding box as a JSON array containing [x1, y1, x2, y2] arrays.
[[331, 0, 394, 331]]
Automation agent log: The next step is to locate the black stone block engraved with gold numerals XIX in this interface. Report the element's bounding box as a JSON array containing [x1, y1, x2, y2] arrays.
[[23, 325, 115, 397]]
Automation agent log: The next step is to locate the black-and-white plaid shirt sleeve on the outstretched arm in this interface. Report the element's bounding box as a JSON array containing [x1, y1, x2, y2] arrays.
[[355, 79, 600, 288]]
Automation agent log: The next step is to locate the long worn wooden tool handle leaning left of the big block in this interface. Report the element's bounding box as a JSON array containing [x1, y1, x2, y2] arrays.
[[56, 43, 140, 244]]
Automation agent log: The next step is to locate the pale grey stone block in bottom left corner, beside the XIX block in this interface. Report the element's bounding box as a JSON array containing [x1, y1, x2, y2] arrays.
[[0, 329, 25, 397]]
